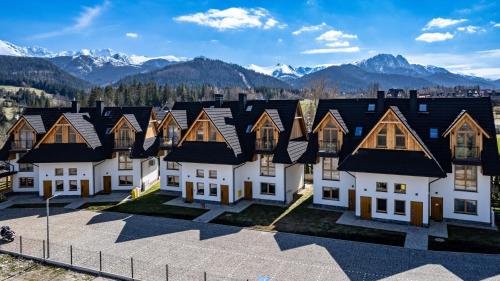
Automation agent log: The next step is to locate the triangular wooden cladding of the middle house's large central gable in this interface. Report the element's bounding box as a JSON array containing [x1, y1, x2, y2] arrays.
[[179, 111, 225, 142]]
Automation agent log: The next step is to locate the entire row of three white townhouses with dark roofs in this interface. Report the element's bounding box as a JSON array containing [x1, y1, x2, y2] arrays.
[[0, 91, 500, 226]]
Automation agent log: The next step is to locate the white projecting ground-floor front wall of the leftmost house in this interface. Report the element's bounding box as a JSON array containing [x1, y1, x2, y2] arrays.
[[36, 163, 94, 196]]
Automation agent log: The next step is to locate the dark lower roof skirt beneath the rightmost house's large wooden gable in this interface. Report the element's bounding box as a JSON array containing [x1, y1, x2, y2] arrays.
[[338, 148, 446, 176]]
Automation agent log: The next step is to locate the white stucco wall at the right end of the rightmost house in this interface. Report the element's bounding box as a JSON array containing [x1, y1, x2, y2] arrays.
[[430, 165, 491, 223]]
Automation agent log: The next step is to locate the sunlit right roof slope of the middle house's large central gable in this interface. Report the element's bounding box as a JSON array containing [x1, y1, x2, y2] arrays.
[[203, 108, 242, 155]]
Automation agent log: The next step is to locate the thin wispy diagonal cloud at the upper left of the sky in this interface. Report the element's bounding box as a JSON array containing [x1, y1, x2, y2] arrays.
[[33, 0, 110, 39]]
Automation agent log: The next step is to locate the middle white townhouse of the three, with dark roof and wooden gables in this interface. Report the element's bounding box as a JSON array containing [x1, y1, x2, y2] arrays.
[[159, 94, 307, 204]]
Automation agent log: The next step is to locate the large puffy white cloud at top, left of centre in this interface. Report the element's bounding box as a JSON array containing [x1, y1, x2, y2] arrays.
[[174, 8, 286, 31]]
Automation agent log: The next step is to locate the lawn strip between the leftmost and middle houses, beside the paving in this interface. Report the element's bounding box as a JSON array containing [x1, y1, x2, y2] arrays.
[[81, 184, 207, 220]]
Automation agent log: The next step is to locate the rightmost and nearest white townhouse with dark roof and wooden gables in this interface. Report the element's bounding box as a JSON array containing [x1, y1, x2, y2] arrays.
[[301, 91, 500, 226]]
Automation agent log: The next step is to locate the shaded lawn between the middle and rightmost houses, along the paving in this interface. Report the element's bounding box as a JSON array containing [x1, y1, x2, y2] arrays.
[[212, 190, 405, 246]]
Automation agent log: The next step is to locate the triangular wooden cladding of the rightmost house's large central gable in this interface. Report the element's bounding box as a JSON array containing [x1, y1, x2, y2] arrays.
[[353, 109, 433, 155]]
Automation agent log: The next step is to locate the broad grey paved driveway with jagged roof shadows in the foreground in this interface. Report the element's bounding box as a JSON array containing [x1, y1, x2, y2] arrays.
[[0, 208, 500, 280]]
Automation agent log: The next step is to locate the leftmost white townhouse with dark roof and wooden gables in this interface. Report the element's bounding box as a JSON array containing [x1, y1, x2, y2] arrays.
[[0, 101, 158, 198]]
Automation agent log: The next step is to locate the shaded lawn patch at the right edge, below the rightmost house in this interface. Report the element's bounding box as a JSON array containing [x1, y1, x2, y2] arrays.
[[429, 225, 500, 254]]
